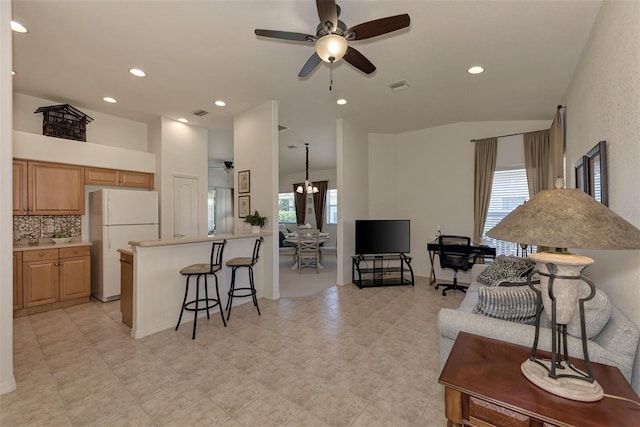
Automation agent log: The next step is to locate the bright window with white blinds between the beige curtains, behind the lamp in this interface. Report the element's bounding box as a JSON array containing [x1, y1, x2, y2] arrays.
[[482, 169, 529, 256]]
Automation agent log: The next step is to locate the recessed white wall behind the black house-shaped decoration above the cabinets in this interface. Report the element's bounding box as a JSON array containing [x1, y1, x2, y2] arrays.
[[13, 93, 147, 151]]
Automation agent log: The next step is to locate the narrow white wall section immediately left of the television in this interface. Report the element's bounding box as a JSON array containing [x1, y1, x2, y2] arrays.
[[336, 119, 370, 285]]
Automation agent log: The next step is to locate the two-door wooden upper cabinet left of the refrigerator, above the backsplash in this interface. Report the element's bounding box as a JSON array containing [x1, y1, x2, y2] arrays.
[[13, 160, 84, 215]]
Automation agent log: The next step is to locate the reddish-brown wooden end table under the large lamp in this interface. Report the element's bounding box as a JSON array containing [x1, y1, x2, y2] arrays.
[[438, 332, 640, 427]]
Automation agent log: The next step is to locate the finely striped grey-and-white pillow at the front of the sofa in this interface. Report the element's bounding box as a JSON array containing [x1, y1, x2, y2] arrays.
[[473, 286, 536, 325]]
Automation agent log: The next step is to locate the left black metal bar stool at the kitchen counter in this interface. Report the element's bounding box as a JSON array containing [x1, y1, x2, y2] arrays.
[[176, 240, 227, 339]]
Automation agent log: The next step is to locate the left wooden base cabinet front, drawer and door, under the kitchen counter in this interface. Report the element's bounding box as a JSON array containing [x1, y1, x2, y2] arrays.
[[22, 249, 58, 308]]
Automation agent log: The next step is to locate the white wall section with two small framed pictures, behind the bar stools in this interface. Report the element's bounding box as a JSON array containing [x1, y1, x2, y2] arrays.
[[233, 101, 280, 299]]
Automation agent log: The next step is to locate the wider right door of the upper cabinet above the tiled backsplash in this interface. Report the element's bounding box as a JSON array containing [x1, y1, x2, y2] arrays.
[[29, 162, 84, 215]]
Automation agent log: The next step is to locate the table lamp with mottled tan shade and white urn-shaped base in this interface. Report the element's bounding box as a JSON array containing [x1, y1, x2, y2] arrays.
[[487, 189, 640, 402]]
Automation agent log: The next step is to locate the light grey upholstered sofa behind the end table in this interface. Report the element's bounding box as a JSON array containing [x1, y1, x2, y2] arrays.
[[438, 264, 640, 393]]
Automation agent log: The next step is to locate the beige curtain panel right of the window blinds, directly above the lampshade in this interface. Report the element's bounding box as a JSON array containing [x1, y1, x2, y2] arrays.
[[522, 130, 553, 198]]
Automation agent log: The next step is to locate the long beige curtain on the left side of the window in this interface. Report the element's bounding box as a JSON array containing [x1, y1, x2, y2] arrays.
[[473, 138, 498, 244]]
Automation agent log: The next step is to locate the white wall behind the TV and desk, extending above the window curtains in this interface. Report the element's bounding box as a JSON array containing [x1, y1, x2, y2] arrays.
[[370, 121, 555, 281]]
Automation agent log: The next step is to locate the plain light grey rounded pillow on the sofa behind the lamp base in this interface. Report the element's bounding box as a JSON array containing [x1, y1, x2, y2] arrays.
[[540, 280, 613, 339]]
